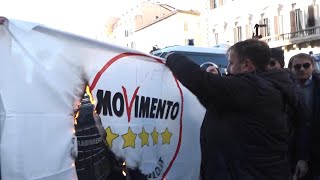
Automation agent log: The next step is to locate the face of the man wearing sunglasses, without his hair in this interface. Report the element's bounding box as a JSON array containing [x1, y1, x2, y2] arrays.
[[291, 58, 313, 81]]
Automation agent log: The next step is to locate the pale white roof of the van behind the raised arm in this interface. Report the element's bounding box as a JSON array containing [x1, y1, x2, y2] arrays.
[[152, 46, 228, 54]]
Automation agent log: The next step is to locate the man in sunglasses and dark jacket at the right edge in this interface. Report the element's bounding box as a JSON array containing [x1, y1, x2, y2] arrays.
[[289, 53, 320, 179]]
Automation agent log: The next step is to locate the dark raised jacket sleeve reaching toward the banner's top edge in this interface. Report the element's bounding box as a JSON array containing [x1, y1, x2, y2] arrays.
[[166, 53, 254, 109]]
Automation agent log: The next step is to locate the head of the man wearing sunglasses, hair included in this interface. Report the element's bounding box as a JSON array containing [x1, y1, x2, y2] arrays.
[[288, 53, 314, 84]]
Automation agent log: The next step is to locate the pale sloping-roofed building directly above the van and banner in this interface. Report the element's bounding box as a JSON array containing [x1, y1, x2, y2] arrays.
[[110, 2, 205, 52]]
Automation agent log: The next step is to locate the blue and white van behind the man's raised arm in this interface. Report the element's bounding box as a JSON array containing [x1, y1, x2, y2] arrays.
[[151, 46, 228, 74]]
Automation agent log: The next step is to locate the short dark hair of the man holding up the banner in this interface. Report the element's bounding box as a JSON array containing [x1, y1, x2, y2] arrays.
[[228, 39, 271, 71]]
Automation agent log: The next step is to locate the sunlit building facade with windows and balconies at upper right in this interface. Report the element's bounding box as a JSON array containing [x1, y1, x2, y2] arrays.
[[202, 0, 320, 64]]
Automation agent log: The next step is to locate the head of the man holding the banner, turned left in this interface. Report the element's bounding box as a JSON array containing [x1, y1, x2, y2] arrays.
[[227, 39, 271, 74]]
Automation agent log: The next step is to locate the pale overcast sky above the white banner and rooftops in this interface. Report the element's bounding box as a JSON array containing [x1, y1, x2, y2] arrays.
[[0, 0, 199, 38]]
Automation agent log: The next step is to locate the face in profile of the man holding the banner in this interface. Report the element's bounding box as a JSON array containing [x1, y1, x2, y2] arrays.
[[227, 50, 244, 74]]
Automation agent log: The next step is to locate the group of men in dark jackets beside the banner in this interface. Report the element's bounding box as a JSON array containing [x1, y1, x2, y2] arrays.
[[166, 39, 320, 180]]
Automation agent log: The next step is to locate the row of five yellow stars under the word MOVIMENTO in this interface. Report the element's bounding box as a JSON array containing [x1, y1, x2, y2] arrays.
[[106, 126, 173, 148]]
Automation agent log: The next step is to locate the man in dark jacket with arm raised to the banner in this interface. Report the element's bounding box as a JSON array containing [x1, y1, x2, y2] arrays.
[[166, 39, 296, 180]]
